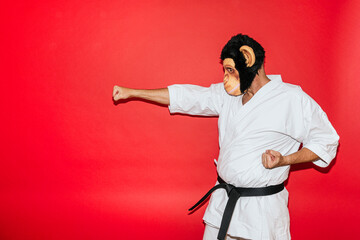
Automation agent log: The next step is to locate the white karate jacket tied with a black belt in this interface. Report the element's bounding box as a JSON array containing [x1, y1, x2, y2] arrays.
[[168, 75, 339, 240]]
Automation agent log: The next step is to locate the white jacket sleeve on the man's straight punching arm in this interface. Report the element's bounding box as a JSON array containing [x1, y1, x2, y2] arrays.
[[168, 83, 225, 116]]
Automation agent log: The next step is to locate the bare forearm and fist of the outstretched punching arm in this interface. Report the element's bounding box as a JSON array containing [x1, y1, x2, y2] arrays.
[[113, 86, 170, 105]]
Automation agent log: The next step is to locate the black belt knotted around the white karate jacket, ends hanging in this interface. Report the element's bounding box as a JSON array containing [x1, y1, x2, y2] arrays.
[[189, 176, 284, 240]]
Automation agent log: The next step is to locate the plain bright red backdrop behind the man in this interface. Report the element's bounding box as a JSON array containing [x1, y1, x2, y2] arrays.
[[0, 0, 360, 240]]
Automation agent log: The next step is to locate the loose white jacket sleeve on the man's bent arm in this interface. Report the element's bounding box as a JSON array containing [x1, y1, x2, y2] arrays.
[[303, 95, 339, 167]]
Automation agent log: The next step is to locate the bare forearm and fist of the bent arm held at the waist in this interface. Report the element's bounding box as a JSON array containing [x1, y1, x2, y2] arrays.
[[262, 148, 319, 168]]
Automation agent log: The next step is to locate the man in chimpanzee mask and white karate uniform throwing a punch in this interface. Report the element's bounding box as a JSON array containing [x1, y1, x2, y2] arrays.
[[113, 34, 339, 240]]
